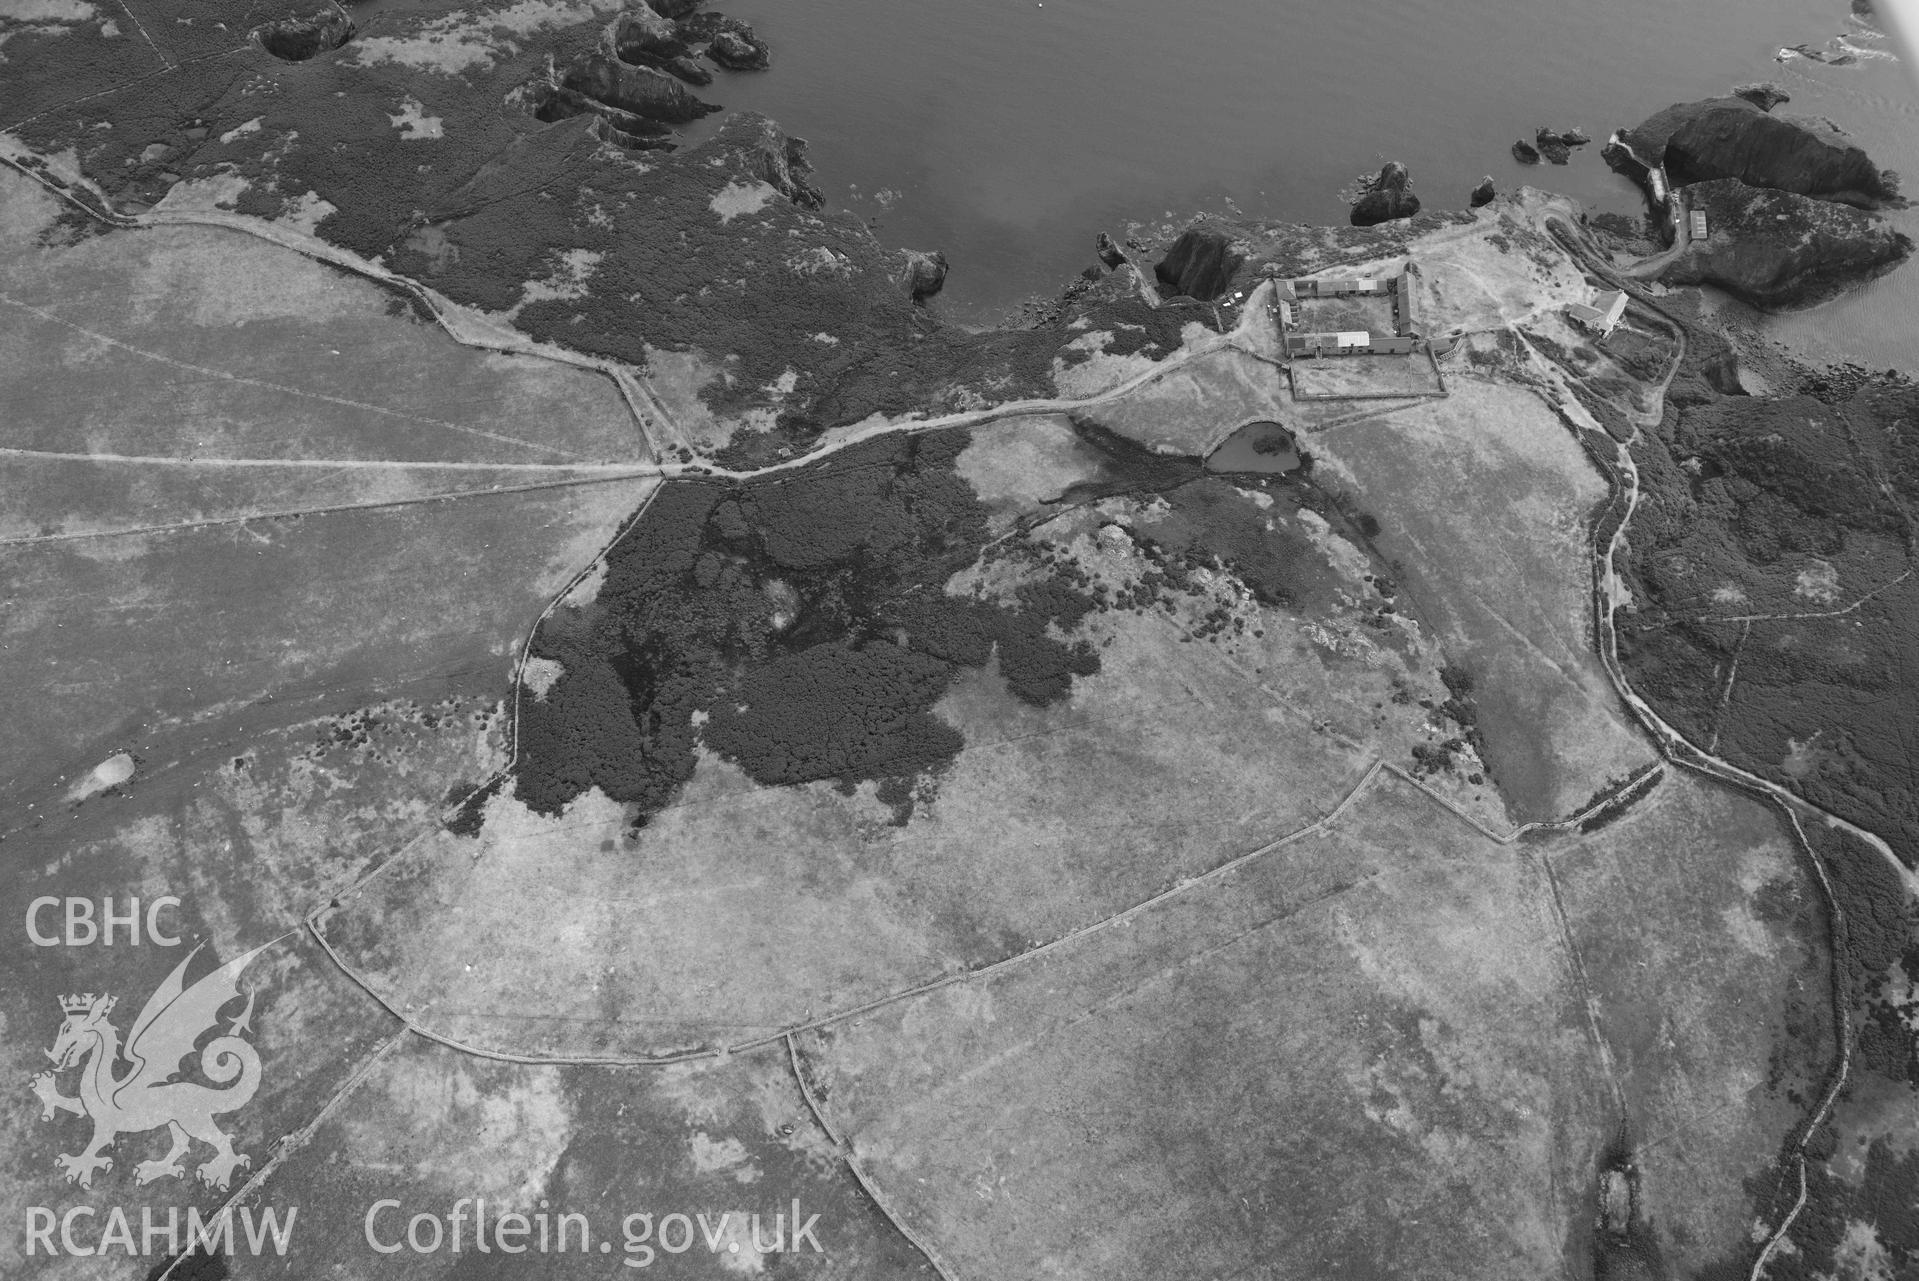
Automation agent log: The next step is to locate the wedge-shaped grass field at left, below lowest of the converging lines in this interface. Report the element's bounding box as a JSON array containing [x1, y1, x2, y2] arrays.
[[0, 479, 652, 798]]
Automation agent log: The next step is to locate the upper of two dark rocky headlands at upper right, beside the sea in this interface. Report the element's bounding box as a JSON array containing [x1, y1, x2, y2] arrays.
[[1622, 98, 1898, 209]]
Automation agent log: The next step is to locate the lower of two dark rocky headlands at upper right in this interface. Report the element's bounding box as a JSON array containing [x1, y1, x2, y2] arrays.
[[1660, 178, 1913, 309]]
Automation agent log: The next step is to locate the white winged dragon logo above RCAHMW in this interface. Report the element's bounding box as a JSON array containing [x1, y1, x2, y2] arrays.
[[33, 943, 272, 1191]]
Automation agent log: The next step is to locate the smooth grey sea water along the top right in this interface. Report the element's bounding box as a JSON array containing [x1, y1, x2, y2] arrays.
[[671, 0, 1919, 366]]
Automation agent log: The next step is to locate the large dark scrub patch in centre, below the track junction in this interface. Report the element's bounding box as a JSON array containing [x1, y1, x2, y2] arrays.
[[516, 431, 1100, 821]]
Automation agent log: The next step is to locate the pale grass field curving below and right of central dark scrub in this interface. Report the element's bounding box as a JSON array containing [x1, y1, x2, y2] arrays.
[[314, 418, 1508, 1053]]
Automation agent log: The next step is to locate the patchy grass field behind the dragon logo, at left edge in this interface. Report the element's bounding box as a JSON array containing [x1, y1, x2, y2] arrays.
[[0, 702, 435, 1277]]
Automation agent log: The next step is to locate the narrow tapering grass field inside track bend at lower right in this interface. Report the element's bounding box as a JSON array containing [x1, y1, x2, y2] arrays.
[[1539, 771, 1835, 1275]]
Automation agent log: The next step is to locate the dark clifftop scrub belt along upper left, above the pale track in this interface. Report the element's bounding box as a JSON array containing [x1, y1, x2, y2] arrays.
[[0, 0, 1178, 454]]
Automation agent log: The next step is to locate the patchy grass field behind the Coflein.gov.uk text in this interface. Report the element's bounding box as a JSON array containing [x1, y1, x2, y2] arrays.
[[241, 1041, 936, 1281]]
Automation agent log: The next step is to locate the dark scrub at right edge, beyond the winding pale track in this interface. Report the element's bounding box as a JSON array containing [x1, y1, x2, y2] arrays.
[[1616, 318, 1919, 865]]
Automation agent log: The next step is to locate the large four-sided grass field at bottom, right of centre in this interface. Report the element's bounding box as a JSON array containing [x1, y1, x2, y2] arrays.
[[802, 770, 1604, 1279]]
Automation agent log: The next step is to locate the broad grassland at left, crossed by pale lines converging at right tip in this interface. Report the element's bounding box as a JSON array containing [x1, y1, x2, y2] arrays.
[[0, 171, 652, 800]]
